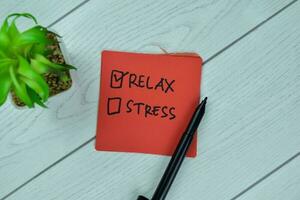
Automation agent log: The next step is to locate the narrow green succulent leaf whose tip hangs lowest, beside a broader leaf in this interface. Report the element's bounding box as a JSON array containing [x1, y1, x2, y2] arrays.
[[9, 67, 34, 108]]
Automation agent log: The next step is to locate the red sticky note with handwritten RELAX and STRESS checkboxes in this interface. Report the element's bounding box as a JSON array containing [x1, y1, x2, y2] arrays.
[[96, 51, 202, 157]]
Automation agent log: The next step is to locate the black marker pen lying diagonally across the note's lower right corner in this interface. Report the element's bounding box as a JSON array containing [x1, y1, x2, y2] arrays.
[[137, 97, 207, 200]]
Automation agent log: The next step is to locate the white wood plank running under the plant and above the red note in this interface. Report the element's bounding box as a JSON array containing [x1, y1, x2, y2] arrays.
[[0, 1, 296, 198]]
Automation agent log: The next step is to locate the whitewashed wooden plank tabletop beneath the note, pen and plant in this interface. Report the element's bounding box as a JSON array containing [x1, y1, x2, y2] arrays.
[[0, 0, 300, 200]]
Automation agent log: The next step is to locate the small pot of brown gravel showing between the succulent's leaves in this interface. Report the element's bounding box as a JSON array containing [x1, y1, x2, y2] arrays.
[[11, 30, 72, 108]]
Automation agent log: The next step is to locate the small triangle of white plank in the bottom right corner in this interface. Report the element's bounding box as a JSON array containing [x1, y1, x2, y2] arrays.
[[238, 157, 300, 200]]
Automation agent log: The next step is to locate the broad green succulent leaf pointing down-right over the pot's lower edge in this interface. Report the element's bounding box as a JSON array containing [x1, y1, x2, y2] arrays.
[[18, 56, 49, 101]]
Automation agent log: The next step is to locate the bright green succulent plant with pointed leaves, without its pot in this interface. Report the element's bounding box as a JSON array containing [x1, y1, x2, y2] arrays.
[[0, 13, 75, 108]]
